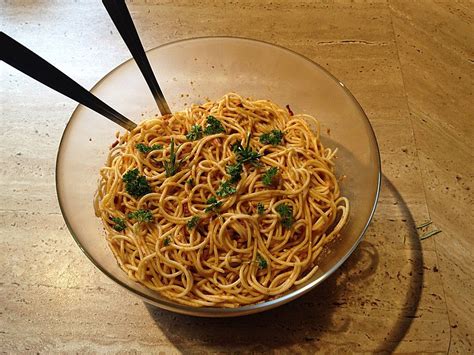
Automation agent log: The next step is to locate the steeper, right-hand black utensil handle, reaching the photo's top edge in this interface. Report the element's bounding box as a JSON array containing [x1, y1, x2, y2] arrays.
[[102, 0, 171, 115]]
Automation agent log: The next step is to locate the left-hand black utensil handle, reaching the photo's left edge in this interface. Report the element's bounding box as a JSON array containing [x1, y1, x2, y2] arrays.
[[0, 32, 137, 130]]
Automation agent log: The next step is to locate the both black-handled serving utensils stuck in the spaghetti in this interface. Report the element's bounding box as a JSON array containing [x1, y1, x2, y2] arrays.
[[0, 0, 171, 130]]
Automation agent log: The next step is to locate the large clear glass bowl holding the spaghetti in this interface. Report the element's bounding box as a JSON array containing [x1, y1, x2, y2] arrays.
[[56, 37, 381, 317]]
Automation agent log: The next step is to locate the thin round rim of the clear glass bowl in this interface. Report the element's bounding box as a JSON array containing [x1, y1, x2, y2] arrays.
[[55, 36, 382, 317]]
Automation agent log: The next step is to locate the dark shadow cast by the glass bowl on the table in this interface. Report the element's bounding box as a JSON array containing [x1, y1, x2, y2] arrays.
[[146, 179, 423, 352]]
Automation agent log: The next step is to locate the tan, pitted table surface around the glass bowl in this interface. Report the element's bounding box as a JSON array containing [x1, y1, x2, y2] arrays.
[[0, 0, 474, 353]]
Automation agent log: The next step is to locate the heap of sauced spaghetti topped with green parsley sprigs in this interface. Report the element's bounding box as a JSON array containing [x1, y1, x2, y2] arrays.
[[94, 93, 349, 307]]
